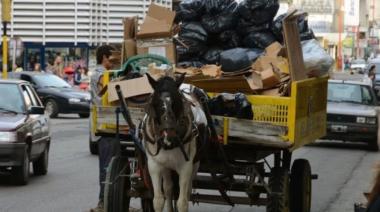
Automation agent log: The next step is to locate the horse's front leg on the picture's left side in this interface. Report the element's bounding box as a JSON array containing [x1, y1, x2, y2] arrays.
[[148, 159, 165, 212]]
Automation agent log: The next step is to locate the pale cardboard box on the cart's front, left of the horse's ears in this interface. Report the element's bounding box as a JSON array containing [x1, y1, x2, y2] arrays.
[[108, 75, 153, 102]]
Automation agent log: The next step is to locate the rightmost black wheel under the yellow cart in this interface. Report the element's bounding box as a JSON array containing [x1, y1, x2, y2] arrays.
[[290, 159, 311, 212]]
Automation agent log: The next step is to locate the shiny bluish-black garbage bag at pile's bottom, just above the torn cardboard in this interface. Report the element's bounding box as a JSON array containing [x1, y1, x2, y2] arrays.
[[220, 48, 252, 72]]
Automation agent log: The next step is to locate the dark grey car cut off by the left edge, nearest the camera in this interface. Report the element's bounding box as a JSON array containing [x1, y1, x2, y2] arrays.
[[0, 80, 50, 185]]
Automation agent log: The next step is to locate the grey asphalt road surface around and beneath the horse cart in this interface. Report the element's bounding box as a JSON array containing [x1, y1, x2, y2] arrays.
[[0, 116, 380, 212]]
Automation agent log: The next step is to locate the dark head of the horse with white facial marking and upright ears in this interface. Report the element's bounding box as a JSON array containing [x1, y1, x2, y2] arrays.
[[147, 74, 185, 141]]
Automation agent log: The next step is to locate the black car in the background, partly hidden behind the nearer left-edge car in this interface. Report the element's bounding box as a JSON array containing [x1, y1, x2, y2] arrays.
[[9, 71, 91, 118]]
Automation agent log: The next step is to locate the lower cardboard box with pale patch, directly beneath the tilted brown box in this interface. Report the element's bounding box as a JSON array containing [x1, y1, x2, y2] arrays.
[[137, 39, 176, 64]]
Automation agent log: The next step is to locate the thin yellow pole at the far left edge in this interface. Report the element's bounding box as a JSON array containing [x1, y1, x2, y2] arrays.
[[1, 0, 12, 79]]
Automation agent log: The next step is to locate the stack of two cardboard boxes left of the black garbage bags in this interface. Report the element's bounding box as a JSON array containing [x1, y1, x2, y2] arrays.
[[136, 3, 176, 64]]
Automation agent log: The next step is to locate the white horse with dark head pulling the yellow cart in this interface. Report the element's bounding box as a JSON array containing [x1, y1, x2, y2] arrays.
[[141, 74, 207, 212]]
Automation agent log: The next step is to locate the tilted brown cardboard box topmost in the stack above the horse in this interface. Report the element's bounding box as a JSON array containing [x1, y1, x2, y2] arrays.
[[137, 3, 176, 39]]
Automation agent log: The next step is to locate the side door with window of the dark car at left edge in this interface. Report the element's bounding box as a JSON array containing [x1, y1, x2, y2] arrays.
[[21, 84, 43, 158]]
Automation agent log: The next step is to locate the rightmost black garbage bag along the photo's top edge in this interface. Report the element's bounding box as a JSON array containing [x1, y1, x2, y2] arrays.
[[237, 0, 280, 25]]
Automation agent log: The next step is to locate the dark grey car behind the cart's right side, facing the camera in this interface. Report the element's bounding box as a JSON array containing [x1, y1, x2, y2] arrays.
[[325, 80, 380, 151]]
